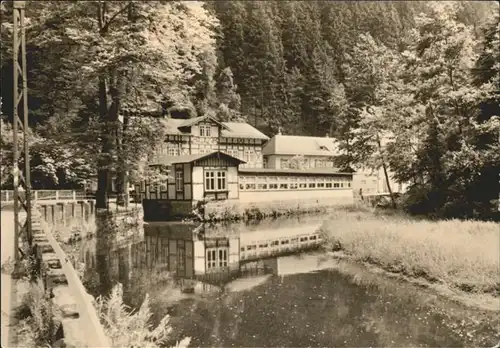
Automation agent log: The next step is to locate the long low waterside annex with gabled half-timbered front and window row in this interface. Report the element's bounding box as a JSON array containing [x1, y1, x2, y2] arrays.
[[136, 151, 353, 220]]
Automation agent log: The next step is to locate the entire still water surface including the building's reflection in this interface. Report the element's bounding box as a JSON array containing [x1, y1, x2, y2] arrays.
[[80, 217, 499, 347]]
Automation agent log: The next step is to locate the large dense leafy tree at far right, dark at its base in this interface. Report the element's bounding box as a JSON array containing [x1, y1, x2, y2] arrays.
[[393, 2, 499, 217]]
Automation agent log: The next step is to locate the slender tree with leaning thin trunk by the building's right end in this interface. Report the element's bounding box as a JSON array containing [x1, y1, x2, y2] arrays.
[[337, 34, 399, 207]]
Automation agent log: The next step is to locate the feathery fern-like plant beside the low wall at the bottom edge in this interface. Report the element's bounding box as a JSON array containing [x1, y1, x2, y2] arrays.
[[96, 284, 191, 347]]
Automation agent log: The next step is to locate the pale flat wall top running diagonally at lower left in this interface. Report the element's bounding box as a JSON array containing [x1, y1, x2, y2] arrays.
[[40, 219, 111, 347]]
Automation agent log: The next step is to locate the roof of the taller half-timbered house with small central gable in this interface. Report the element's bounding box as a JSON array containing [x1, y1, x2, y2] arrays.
[[162, 116, 269, 140]]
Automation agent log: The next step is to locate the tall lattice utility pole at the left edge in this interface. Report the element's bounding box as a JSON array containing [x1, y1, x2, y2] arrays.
[[12, 1, 32, 262]]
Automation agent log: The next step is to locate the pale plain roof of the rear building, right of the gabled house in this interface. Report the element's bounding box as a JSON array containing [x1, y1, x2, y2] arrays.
[[262, 134, 338, 156]]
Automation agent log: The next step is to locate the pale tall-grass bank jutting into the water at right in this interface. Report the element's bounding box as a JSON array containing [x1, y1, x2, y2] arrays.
[[321, 207, 500, 310]]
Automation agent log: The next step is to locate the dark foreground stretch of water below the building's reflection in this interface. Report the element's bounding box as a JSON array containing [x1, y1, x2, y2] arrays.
[[165, 260, 498, 347]]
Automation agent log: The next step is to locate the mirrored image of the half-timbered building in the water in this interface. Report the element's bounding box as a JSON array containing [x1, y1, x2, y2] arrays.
[[84, 222, 322, 286]]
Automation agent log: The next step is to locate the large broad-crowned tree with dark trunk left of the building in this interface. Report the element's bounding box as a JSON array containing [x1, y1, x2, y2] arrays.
[[26, 1, 217, 208]]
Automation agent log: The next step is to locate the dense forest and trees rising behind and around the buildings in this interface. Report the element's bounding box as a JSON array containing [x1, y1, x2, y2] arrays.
[[1, 1, 500, 218]]
